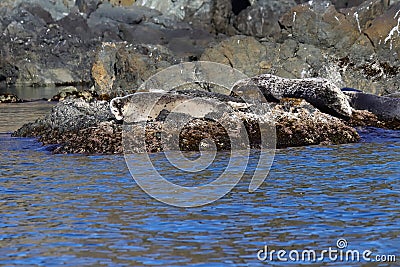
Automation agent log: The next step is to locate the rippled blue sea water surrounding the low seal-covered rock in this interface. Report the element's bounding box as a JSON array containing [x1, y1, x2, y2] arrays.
[[0, 102, 400, 266]]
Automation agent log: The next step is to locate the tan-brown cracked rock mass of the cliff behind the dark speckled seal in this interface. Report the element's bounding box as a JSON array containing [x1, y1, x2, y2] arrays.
[[198, 0, 400, 95]]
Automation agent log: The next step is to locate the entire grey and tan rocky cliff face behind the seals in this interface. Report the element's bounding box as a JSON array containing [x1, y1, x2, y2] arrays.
[[0, 0, 400, 96]]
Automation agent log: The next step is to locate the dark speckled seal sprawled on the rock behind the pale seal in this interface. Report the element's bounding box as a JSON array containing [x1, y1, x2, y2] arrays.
[[232, 74, 352, 119]]
